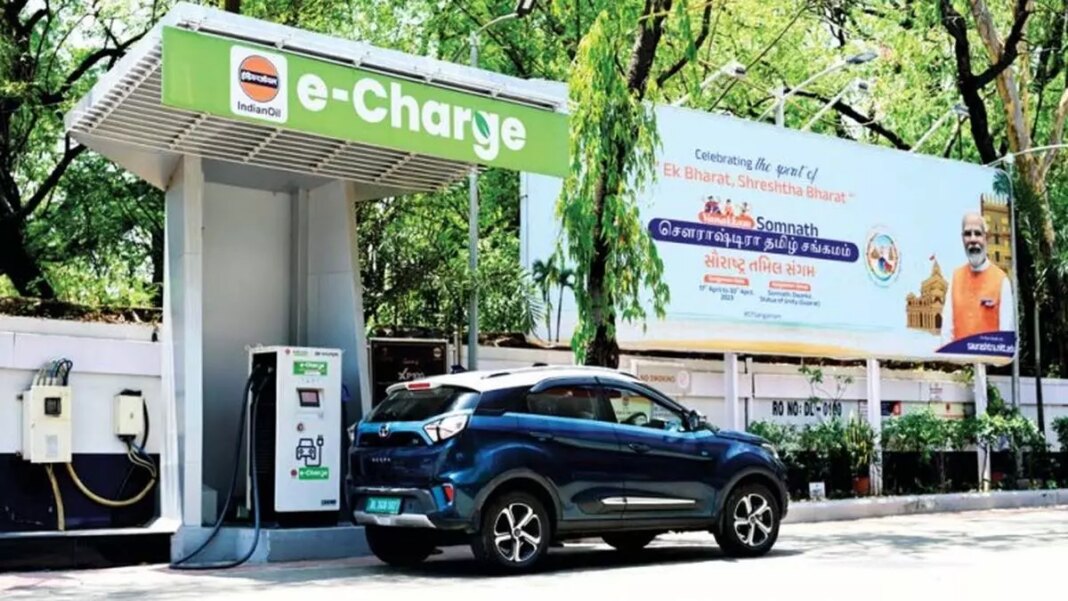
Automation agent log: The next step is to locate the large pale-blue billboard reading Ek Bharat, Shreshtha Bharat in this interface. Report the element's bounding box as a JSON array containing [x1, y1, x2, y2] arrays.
[[521, 107, 1016, 364]]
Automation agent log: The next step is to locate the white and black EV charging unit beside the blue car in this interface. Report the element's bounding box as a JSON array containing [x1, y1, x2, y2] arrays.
[[246, 346, 342, 523]]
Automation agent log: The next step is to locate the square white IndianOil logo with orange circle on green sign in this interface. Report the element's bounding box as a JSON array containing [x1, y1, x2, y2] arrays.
[[230, 46, 289, 123]]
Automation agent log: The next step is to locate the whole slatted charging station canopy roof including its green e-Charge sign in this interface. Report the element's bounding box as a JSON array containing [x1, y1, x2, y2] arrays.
[[66, 4, 567, 197]]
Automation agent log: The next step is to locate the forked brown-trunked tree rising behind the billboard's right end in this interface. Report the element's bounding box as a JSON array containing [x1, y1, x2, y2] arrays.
[[939, 0, 1068, 365]]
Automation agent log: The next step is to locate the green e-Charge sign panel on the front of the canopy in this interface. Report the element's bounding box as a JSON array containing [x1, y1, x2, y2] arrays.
[[162, 27, 568, 177]]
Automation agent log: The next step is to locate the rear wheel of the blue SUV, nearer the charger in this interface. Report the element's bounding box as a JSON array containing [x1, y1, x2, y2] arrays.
[[471, 491, 552, 573]]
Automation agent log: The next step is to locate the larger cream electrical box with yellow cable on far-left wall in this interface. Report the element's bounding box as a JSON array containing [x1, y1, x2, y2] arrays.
[[20, 386, 72, 463]]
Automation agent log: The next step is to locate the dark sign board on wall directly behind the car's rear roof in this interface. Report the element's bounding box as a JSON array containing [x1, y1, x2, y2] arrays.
[[367, 338, 449, 407]]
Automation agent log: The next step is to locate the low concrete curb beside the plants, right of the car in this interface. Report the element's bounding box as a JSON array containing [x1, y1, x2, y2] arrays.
[[783, 489, 1068, 524]]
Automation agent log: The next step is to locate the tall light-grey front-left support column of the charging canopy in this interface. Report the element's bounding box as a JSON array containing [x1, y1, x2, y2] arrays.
[[163, 156, 204, 527]]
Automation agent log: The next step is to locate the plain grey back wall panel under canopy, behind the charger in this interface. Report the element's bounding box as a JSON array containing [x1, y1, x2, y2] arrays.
[[203, 183, 293, 503]]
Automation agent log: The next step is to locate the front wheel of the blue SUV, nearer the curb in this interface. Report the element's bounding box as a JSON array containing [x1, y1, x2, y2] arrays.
[[712, 484, 781, 557]]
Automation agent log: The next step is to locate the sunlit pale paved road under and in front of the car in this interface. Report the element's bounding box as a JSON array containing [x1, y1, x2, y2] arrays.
[[0, 507, 1068, 601]]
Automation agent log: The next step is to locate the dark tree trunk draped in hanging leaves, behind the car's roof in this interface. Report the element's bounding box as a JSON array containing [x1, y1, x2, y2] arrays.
[[585, 0, 673, 368]]
